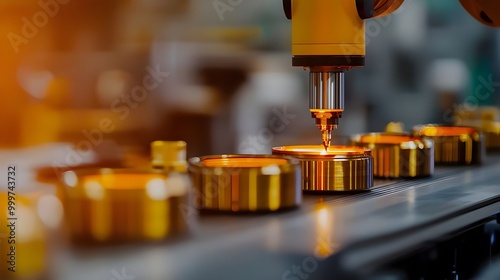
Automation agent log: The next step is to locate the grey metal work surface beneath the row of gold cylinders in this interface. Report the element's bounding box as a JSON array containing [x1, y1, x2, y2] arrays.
[[53, 155, 500, 280]]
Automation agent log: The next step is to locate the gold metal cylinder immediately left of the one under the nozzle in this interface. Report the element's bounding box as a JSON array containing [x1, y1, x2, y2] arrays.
[[188, 155, 296, 212]]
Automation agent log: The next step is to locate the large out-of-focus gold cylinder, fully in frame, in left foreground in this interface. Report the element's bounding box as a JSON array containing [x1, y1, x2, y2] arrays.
[[62, 169, 191, 244]]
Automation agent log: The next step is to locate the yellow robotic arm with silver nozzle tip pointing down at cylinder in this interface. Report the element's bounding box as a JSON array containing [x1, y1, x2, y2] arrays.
[[283, 0, 500, 150]]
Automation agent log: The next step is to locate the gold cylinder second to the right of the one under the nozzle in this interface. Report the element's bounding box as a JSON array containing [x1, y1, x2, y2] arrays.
[[413, 125, 485, 165]]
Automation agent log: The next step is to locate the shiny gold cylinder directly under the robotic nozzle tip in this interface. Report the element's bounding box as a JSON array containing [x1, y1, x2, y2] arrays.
[[273, 145, 373, 191]]
